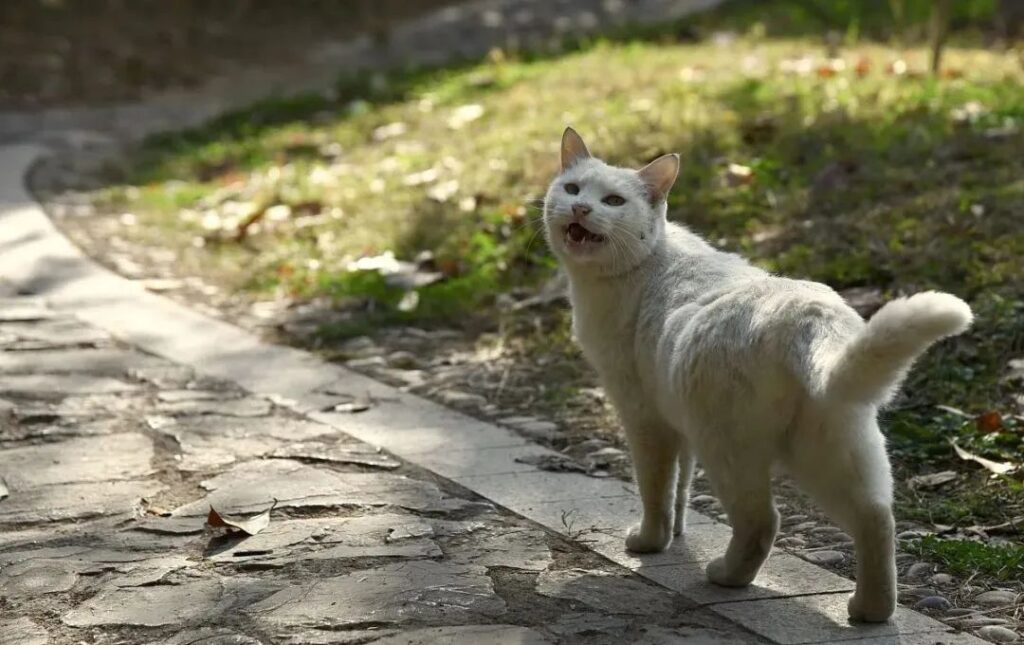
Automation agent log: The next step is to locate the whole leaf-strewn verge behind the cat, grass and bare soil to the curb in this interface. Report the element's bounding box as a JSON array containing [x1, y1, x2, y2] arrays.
[[22, 3, 1024, 642]]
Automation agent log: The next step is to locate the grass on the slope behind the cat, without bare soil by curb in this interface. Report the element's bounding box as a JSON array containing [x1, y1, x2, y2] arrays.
[[92, 3, 1024, 577]]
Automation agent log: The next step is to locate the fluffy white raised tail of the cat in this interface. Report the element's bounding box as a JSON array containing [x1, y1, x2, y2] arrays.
[[824, 291, 974, 405]]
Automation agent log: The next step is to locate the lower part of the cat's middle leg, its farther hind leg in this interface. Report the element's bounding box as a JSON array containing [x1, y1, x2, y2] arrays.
[[701, 456, 778, 587]]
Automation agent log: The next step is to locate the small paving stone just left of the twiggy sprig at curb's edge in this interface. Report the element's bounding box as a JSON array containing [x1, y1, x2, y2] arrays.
[[449, 526, 552, 571]]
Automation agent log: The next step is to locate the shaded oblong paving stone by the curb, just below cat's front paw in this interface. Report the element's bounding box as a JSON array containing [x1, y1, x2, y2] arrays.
[[537, 568, 673, 614]]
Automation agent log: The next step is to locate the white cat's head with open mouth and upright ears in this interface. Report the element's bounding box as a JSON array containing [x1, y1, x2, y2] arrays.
[[544, 128, 679, 275]]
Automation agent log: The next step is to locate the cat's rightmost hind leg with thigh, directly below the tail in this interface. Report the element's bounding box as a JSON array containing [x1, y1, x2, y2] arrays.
[[786, 405, 896, 622]]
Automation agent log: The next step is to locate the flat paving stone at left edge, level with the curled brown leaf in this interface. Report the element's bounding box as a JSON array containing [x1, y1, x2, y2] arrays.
[[0, 480, 164, 524]]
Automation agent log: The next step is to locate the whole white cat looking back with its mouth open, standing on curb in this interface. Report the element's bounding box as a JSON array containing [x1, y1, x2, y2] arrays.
[[544, 128, 972, 621]]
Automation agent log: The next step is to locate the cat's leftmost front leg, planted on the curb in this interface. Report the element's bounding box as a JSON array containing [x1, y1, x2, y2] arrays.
[[621, 411, 680, 553]]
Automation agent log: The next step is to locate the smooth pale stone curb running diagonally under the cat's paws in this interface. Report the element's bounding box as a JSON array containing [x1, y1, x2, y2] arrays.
[[0, 145, 984, 645]]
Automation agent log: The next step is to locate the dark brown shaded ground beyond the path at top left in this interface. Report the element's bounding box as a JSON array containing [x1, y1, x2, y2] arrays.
[[0, 0, 459, 109]]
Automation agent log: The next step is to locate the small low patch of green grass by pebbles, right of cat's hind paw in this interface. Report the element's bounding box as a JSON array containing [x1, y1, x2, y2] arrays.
[[906, 535, 1024, 582]]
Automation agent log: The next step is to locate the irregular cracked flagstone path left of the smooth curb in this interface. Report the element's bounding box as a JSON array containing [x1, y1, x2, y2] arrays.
[[0, 289, 758, 645]]
